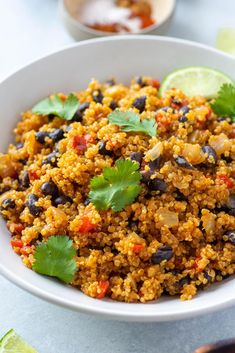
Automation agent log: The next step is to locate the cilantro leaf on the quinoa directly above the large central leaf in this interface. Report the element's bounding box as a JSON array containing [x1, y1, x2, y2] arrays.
[[108, 110, 157, 137]]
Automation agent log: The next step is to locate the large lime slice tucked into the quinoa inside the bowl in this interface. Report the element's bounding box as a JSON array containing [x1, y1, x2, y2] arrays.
[[160, 66, 233, 99]]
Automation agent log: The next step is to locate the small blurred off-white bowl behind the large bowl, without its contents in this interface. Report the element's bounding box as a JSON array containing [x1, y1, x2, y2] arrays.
[[59, 0, 176, 40]]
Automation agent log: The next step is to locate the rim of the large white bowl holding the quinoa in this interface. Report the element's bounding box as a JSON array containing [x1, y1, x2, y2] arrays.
[[0, 35, 235, 322]]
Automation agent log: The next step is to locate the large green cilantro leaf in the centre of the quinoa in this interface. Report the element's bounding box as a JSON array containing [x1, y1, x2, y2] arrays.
[[89, 159, 141, 212]]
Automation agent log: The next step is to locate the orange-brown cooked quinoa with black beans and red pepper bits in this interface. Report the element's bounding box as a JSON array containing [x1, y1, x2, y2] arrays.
[[0, 77, 235, 303]]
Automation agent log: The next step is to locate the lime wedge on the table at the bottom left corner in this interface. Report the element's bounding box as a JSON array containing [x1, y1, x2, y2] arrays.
[[0, 330, 38, 353]]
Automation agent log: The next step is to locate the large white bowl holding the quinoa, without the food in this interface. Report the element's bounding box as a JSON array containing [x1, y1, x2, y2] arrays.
[[0, 36, 235, 321]]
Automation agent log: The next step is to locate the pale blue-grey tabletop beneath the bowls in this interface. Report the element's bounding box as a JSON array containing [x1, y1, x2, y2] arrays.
[[0, 0, 235, 353]]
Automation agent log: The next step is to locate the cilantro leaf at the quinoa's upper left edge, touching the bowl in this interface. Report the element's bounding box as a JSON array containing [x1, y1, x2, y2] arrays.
[[32, 93, 79, 120]]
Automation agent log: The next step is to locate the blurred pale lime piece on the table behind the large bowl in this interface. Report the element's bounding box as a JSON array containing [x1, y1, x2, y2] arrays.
[[216, 28, 235, 55]]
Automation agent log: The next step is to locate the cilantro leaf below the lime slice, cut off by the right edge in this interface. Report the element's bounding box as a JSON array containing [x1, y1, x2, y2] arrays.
[[211, 84, 235, 122]]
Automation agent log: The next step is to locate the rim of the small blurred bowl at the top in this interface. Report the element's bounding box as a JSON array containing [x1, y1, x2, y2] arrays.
[[58, 0, 176, 37]]
